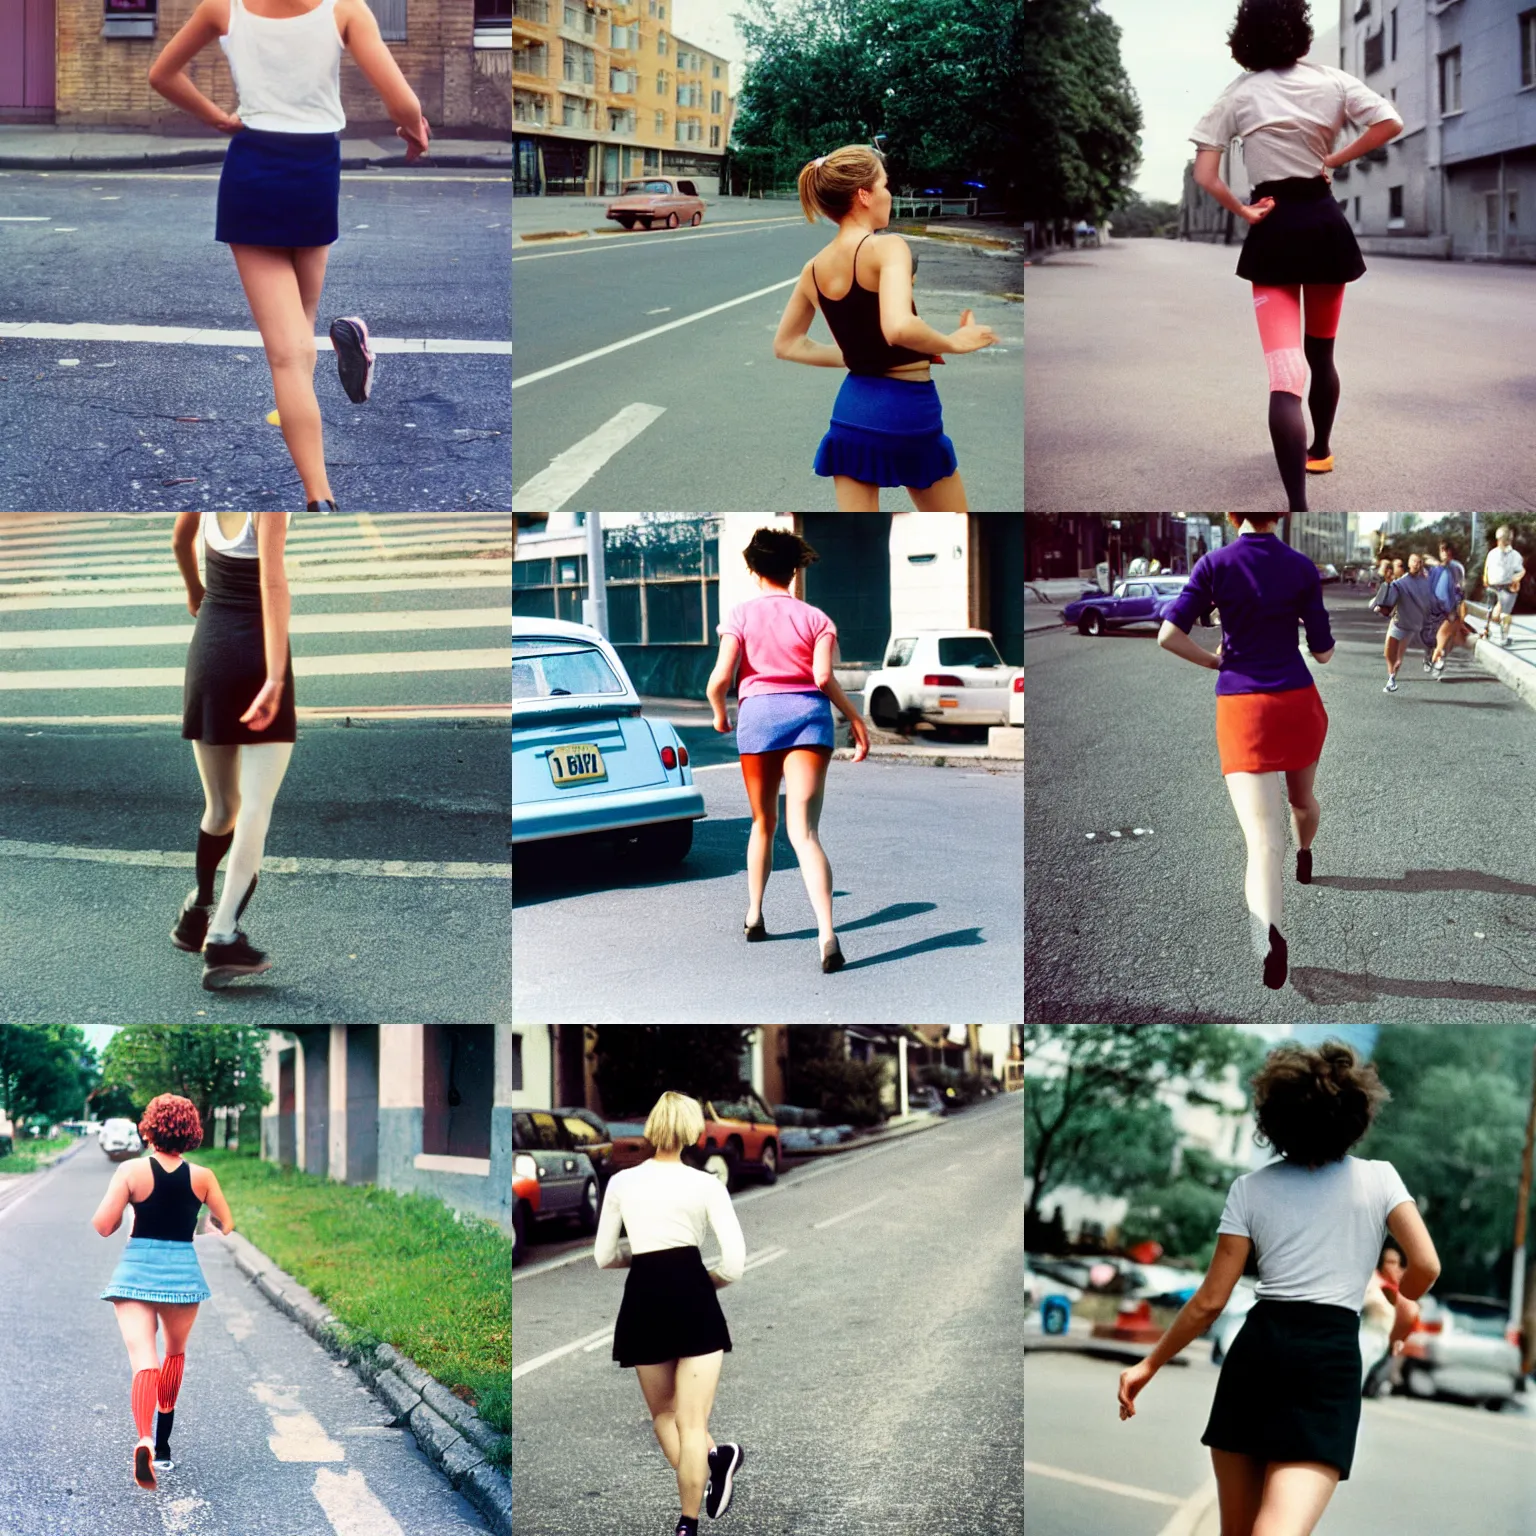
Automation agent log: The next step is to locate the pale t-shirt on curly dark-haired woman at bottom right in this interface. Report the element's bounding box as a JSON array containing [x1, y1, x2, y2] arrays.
[[1217, 1157, 1413, 1312]]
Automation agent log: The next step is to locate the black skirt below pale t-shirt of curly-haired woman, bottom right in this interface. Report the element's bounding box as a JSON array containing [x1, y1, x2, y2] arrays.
[[1200, 1301, 1361, 1479]]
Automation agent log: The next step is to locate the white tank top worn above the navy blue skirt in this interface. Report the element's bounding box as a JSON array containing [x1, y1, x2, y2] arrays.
[[218, 0, 347, 134]]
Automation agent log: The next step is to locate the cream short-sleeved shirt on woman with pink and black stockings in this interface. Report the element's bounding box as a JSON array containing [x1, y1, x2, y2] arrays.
[[1189, 61, 1402, 186]]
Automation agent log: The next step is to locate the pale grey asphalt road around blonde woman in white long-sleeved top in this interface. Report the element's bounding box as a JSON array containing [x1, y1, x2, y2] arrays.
[[511, 1095, 1032, 1536]]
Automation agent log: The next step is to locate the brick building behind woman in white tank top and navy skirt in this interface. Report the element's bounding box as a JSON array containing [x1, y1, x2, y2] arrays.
[[0, 0, 511, 138]]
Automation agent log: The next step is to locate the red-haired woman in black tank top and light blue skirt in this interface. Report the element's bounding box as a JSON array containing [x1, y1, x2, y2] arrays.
[[91, 1094, 235, 1488]]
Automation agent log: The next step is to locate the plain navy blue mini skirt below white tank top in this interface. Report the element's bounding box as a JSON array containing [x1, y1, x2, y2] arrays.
[[214, 127, 341, 247]]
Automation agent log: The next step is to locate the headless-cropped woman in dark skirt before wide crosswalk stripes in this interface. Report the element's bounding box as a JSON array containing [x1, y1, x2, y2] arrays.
[[170, 511, 298, 991]]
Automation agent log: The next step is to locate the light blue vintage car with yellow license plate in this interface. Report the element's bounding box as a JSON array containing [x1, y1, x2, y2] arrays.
[[511, 617, 705, 865]]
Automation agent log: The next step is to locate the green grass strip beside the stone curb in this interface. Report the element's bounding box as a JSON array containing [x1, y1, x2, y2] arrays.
[[192, 1147, 511, 1470]]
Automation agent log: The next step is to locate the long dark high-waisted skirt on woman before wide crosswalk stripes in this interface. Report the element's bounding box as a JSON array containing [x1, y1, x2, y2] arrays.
[[181, 550, 298, 746]]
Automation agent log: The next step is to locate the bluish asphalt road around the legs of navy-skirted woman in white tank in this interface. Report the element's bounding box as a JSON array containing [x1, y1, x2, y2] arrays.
[[0, 167, 511, 511]]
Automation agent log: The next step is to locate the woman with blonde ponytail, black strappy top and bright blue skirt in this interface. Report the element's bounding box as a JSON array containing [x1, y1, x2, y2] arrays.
[[773, 144, 997, 511]]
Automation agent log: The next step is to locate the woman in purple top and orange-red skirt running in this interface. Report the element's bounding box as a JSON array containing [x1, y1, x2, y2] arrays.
[[1157, 513, 1333, 991]]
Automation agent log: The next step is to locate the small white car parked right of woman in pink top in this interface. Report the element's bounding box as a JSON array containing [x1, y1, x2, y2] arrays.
[[863, 628, 1023, 734]]
